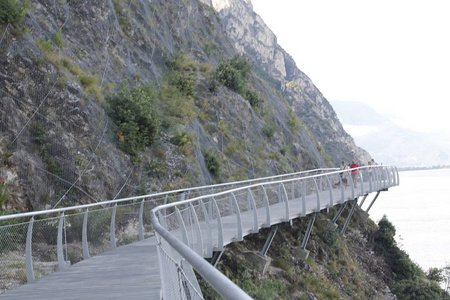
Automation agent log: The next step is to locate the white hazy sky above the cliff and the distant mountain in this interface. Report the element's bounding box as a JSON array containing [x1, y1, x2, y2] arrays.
[[251, 0, 450, 133]]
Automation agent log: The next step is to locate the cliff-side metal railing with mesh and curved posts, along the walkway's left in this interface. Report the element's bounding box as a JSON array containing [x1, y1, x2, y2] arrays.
[[0, 169, 333, 293]]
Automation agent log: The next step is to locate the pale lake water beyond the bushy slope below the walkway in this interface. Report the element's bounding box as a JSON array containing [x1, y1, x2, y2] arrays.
[[370, 169, 450, 271]]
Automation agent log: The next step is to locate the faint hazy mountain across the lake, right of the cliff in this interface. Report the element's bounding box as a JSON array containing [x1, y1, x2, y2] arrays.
[[331, 101, 450, 167]]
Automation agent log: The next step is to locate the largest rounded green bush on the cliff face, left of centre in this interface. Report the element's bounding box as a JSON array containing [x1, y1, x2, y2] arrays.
[[108, 83, 160, 156]]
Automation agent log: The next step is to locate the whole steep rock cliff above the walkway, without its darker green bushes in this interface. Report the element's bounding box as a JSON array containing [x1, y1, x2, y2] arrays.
[[0, 0, 370, 210]]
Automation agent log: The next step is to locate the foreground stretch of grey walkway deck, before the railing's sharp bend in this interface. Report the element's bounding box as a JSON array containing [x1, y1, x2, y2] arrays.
[[0, 237, 161, 300]]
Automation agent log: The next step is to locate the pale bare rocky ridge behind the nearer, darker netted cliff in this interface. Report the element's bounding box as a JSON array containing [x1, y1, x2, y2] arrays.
[[212, 0, 370, 164]]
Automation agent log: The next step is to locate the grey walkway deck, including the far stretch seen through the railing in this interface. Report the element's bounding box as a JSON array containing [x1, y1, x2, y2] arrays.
[[0, 178, 386, 300]]
